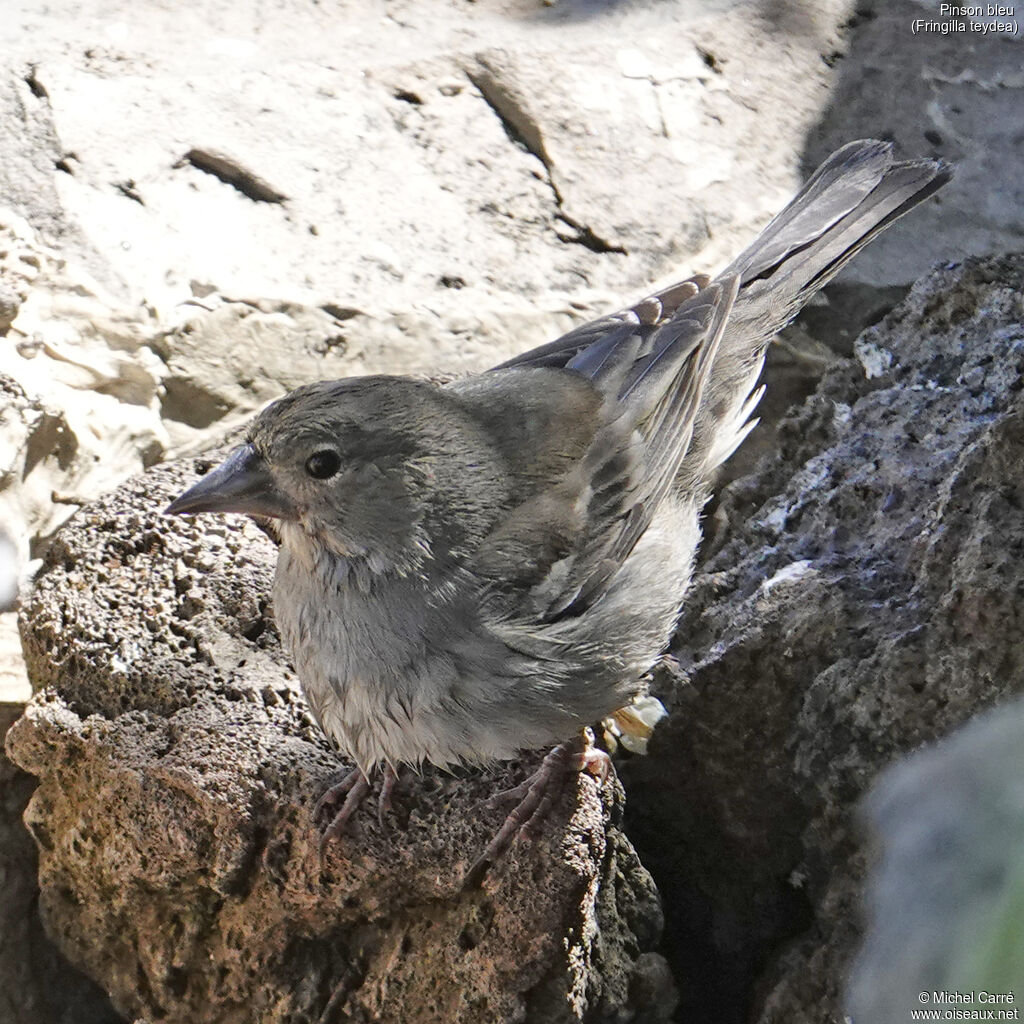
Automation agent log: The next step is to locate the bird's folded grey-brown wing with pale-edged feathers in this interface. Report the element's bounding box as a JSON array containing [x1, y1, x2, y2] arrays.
[[479, 275, 738, 622]]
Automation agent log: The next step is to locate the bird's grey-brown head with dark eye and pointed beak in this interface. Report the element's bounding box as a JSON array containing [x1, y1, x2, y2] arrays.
[[167, 377, 499, 571]]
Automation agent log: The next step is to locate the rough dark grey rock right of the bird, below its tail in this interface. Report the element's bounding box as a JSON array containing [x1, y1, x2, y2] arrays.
[[622, 249, 1024, 1024]]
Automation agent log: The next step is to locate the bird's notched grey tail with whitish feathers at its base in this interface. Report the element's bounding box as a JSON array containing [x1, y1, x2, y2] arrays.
[[684, 139, 952, 477]]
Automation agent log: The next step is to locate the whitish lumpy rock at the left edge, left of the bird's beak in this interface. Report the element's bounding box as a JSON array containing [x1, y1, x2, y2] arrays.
[[0, 239, 167, 564]]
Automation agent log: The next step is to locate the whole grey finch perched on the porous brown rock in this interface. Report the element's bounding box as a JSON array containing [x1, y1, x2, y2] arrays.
[[161, 140, 951, 878]]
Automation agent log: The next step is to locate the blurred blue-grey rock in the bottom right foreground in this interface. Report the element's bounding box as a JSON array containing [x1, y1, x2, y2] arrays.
[[847, 700, 1024, 1024]]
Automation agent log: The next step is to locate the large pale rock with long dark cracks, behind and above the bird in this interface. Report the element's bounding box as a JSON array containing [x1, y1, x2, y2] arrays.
[[2, 0, 847, 309]]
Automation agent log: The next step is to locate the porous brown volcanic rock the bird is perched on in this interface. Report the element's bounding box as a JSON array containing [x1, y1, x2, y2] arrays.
[[7, 461, 672, 1024]]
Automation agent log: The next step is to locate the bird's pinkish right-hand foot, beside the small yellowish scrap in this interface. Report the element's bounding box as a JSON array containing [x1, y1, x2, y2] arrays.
[[464, 730, 611, 889]]
